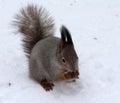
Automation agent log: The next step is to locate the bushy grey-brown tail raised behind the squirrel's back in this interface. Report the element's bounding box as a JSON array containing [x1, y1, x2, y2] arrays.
[[14, 5, 54, 58]]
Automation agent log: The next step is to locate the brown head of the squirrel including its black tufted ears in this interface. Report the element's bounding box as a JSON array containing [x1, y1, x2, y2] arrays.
[[57, 26, 78, 72]]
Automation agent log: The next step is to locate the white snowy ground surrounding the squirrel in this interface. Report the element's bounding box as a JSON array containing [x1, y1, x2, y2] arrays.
[[0, 0, 120, 103]]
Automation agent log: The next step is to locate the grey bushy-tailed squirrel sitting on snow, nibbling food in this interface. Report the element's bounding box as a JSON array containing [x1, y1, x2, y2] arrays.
[[14, 5, 79, 91]]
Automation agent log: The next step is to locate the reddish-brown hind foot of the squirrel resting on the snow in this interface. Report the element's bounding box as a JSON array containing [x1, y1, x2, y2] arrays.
[[40, 80, 54, 91]]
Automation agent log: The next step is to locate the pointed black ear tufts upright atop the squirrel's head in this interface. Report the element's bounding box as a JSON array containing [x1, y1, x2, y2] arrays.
[[60, 26, 73, 44]]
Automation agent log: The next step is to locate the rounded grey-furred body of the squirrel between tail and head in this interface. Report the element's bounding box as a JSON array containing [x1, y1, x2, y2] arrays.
[[29, 37, 64, 81]]
